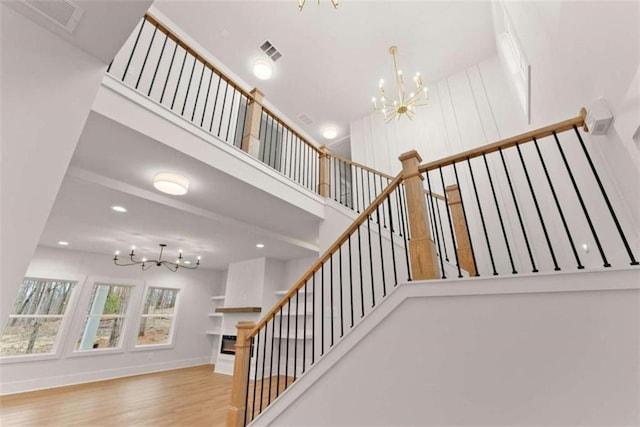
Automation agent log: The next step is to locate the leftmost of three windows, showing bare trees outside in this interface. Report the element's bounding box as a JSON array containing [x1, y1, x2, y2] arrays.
[[0, 278, 77, 356]]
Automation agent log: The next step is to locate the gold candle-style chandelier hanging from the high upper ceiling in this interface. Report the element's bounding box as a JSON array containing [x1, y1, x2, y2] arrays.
[[371, 46, 429, 123]]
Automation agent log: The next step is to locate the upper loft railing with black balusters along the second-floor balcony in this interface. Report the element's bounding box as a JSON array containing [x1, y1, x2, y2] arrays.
[[107, 14, 390, 212]]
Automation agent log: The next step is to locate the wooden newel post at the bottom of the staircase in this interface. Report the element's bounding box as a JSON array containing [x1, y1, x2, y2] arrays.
[[227, 322, 256, 427]]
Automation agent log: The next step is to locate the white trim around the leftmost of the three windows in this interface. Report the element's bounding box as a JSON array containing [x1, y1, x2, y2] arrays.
[[0, 272, 87, 365]]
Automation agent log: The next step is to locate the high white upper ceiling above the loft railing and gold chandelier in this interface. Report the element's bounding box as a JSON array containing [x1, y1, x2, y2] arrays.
[[154, 0, 496, 143]]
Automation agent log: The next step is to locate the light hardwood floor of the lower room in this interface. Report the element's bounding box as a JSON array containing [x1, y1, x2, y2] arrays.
[[0, 365, 232, 427]]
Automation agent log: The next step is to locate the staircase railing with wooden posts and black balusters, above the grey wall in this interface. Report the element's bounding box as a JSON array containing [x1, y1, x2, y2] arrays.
[[227, 108, 638, 426]]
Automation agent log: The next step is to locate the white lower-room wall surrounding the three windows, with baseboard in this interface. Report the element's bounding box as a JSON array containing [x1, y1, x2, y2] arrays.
[[0, 247, 222, 394]]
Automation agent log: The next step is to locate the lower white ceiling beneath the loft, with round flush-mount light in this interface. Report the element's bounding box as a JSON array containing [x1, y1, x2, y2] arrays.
[[40, 112, 320, 269]]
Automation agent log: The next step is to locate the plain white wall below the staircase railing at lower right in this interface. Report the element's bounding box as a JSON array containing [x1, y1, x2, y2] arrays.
[[262, 269, 640, 426]]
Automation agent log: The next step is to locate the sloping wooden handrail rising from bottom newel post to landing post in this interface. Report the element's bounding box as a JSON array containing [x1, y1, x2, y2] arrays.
[[247, 172, 404, 339]]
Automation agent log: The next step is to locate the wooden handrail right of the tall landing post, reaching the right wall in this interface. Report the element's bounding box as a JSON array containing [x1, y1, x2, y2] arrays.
[[418, 108, 587, 173]]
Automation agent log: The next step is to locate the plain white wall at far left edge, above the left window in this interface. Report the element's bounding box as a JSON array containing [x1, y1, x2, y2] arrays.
[[0, 2, 106, 323]]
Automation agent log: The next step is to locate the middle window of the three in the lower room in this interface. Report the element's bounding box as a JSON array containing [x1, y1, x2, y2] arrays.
[[76, 283, 132, 351]]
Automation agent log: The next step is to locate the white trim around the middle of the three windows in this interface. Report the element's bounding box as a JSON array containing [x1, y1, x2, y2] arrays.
[[64, 276, 144, 358]]
